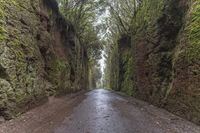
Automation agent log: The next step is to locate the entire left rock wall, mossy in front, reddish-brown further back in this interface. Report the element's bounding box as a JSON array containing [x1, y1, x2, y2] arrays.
[[0, 0, 87, 119]]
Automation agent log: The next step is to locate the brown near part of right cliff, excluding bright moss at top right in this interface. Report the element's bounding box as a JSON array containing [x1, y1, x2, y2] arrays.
[[132, 0, 200, 123]]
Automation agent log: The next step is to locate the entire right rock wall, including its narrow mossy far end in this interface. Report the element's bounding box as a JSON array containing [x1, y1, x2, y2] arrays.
[[113, 0, 200, 124]]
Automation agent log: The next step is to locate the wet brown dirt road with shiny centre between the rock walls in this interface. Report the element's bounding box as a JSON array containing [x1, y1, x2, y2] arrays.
[[0, 89, 200, 133]]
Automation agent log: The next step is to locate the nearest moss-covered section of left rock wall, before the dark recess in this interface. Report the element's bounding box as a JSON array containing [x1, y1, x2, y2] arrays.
[[0, 0, 46, 117]]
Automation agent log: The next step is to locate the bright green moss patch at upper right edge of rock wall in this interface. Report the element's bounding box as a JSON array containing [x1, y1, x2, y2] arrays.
[[187, 0, 200, 61]]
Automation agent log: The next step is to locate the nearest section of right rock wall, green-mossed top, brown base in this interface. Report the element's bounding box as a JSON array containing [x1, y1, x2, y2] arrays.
[[178, 0, 200, 123]]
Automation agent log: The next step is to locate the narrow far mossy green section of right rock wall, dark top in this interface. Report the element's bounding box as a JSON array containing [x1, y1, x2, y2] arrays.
[[118, 35, 134, 96]]
